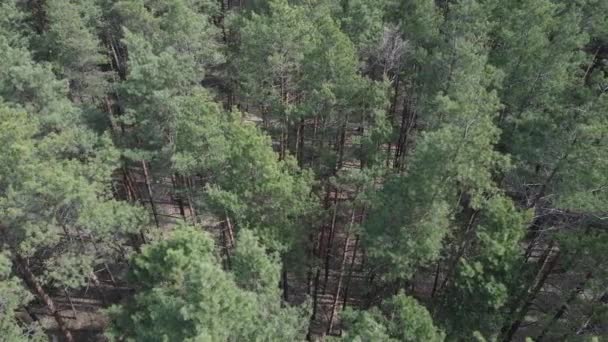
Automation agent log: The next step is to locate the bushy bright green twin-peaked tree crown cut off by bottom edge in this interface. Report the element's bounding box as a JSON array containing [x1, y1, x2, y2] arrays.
[[109, 227, 305, 341]]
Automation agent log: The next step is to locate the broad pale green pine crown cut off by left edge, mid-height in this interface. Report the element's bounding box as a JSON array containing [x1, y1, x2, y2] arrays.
[[0, 97, 145, 288]]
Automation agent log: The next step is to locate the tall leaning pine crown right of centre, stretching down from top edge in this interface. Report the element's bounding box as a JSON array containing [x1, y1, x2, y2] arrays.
[[364, 1, 508, 279]]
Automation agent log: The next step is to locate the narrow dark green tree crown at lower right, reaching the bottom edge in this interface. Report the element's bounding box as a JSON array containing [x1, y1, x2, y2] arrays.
[[441, 195, 532, 338]]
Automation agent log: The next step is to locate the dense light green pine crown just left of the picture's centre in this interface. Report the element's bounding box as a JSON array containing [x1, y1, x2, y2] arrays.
[[204, 120, 315, 251]]
